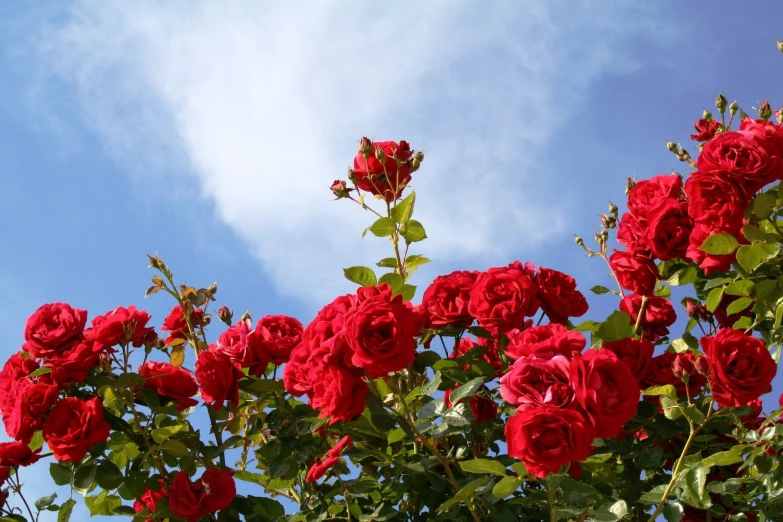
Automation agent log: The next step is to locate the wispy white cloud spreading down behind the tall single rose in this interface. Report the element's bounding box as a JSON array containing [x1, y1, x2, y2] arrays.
[[32, 0, 668, 305]]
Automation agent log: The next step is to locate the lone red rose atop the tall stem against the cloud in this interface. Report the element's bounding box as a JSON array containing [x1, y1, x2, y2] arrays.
[[352, 138, 412, 201]]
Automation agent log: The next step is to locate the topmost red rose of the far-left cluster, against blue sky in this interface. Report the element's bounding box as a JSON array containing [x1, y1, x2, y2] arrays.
[[22, 303, 87, 359]]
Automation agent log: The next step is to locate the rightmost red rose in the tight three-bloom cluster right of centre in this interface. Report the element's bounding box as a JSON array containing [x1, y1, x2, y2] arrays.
[[571, 350, 639, 438]]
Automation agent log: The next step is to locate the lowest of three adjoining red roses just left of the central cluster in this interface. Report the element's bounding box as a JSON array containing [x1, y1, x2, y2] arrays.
[[195, 345, 245, 410]]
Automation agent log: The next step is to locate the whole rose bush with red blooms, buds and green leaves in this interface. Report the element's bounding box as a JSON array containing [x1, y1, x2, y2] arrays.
[[0, 89, 783, 522]]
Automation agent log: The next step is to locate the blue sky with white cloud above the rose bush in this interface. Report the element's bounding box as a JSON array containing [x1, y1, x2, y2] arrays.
[[0, 0, 783, 516]]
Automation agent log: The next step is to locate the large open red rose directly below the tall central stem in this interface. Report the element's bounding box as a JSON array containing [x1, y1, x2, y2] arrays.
[[345, 283, 422, 379]]
